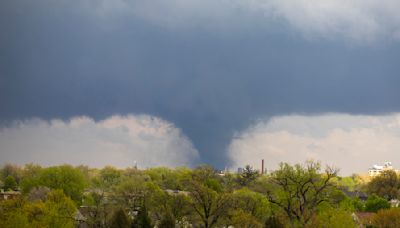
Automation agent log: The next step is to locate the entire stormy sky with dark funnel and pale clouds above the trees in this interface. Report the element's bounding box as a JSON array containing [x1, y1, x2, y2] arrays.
[[0, 0, 400, 175]]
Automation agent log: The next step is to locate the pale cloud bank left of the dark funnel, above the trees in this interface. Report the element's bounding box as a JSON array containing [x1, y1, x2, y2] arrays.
[[0, 115, 198, 168]]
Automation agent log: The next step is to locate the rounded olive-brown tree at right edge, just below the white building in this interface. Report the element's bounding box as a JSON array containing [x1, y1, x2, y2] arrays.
[[367, 170, 400, 200]]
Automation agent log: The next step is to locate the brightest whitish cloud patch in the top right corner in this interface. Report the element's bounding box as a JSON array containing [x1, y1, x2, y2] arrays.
[[255, 0, 400, 43]]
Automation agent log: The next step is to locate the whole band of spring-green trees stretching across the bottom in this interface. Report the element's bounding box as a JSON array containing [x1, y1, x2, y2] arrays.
[[0, 161, 400, 228]]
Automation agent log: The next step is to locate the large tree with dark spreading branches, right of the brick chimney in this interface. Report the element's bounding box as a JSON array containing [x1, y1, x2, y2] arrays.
[[266, 161, 337, 226]]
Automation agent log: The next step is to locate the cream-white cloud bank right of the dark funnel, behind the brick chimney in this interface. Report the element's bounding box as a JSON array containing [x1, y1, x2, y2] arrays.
[[228, 114, 400, 175]]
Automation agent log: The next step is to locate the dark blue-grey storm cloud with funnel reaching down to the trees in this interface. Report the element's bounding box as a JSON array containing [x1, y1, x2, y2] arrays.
[[0, 0, 400, 167]]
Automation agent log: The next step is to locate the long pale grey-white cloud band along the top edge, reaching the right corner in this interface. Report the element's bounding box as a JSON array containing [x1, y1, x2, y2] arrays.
[[90, 0, 400, 43]]
